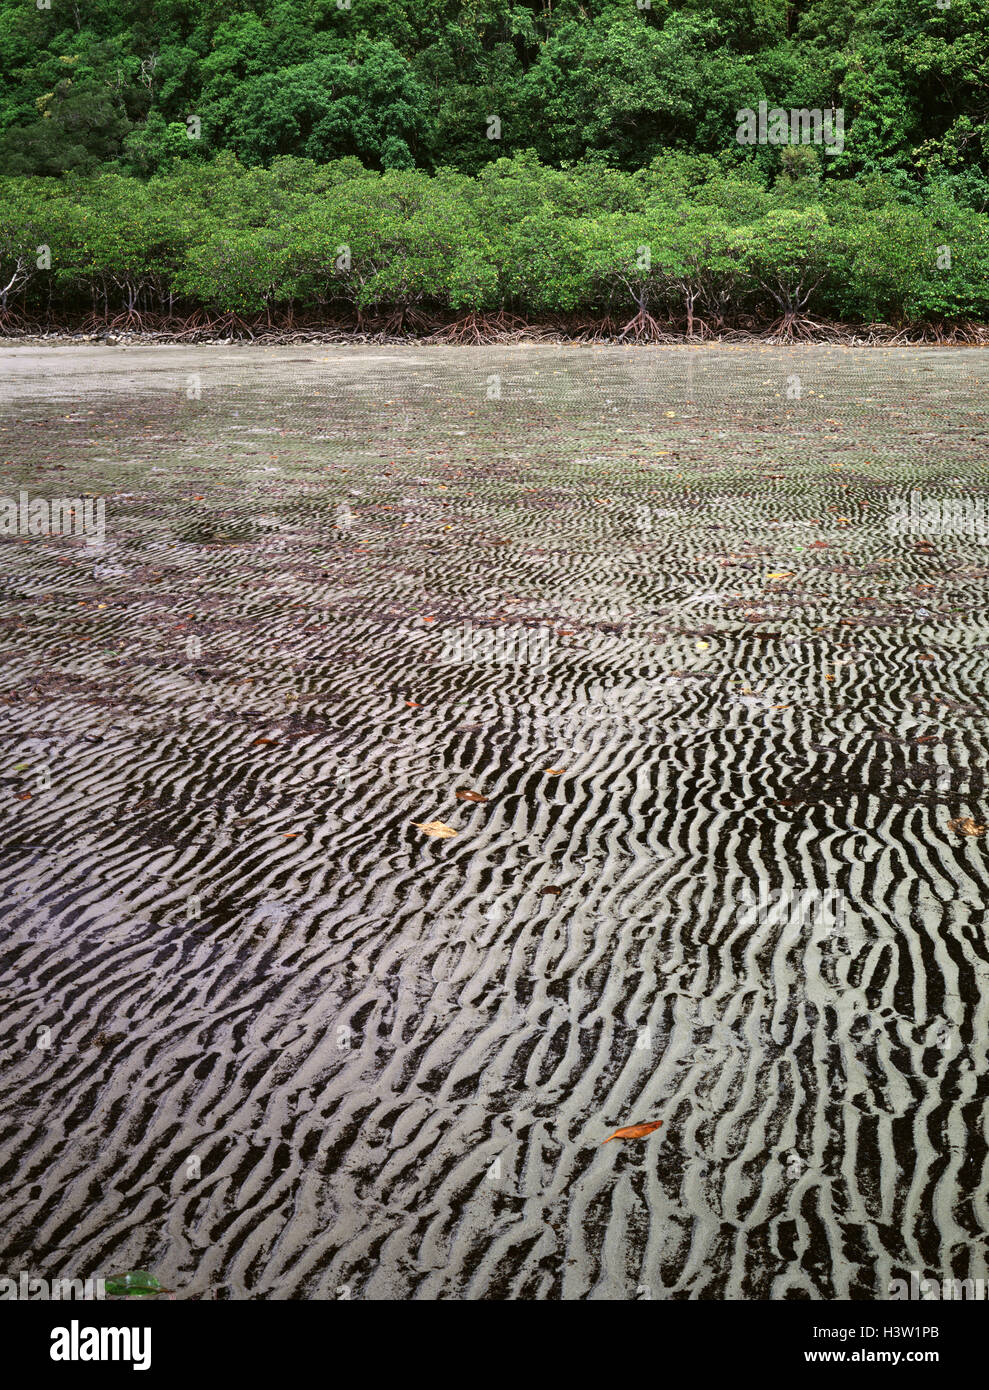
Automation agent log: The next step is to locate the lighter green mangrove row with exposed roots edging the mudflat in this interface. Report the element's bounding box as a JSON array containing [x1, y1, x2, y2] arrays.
[[0, 152, 989, 334]]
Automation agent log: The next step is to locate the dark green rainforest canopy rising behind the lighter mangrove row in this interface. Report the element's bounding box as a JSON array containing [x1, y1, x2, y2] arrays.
[[0, 0, 989, 202]]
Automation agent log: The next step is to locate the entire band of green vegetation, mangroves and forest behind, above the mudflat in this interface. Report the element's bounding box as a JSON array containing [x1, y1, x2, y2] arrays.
[[0, 0, 989, 341]]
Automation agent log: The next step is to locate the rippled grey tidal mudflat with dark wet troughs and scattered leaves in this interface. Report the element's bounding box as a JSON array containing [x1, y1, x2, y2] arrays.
[[0, 346, 989, 1300]]
